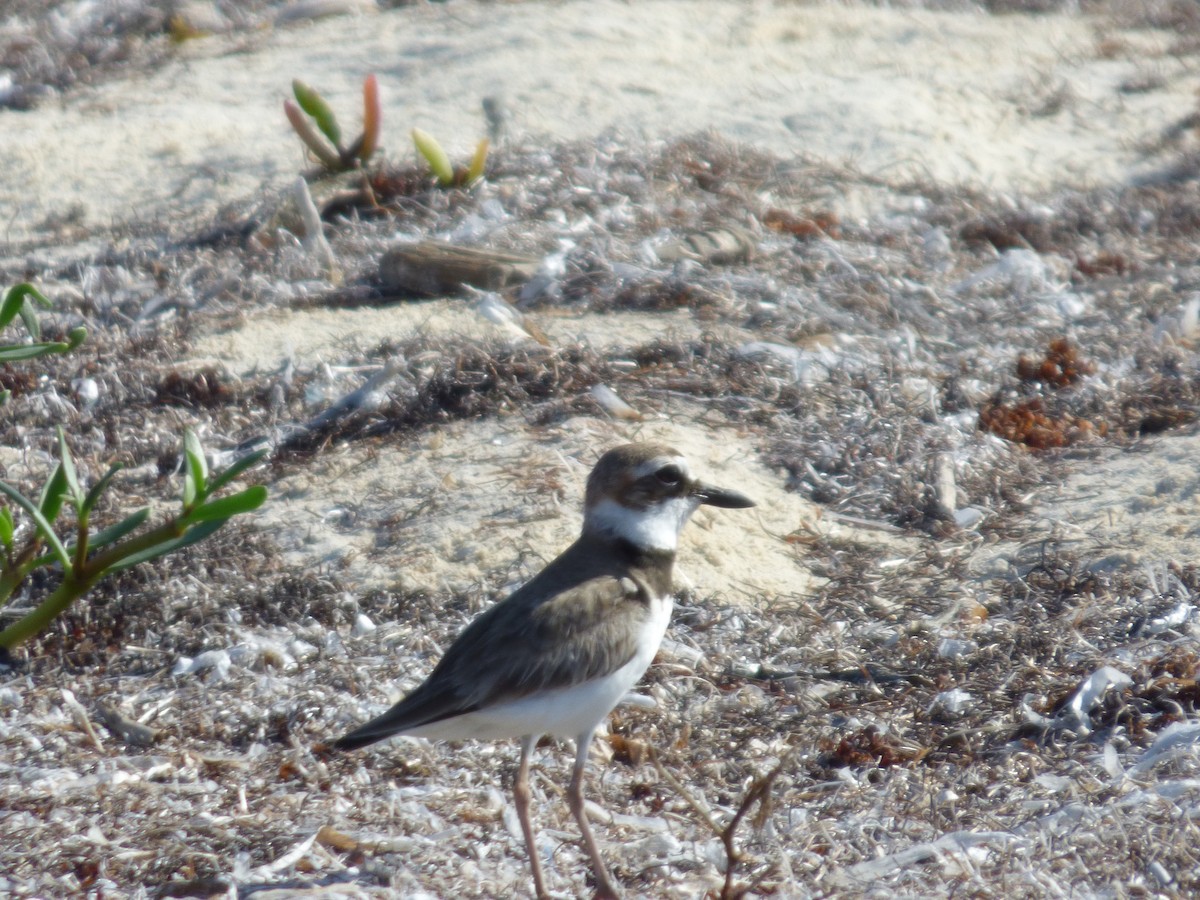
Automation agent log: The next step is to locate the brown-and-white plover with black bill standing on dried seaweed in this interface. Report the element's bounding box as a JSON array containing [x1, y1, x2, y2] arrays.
[[334, 444, 755, 900]]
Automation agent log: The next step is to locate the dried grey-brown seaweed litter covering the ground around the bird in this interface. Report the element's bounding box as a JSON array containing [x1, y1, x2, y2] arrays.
[[7, 103, 1200, 898]]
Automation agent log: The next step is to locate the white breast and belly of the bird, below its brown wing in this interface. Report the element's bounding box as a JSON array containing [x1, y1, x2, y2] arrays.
[[404, 595, 674, 740]]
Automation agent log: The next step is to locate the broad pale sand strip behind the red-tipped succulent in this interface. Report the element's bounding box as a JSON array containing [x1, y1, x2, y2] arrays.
[[0, 0, 1194, 250]]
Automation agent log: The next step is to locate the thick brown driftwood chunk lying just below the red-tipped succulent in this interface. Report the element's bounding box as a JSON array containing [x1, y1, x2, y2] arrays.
[[379, 241, 539, 296]]
